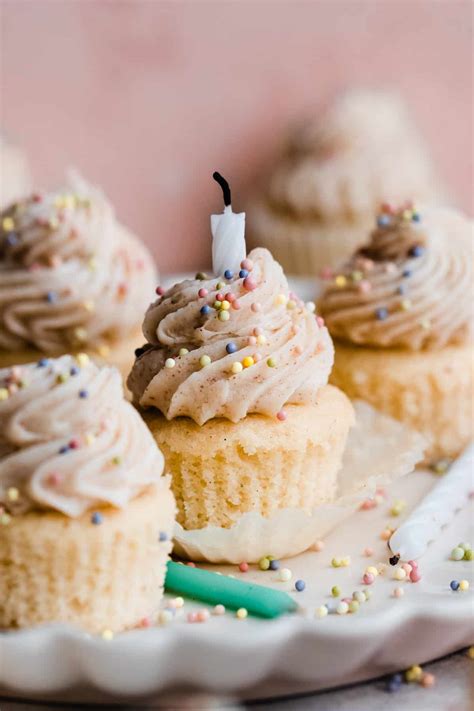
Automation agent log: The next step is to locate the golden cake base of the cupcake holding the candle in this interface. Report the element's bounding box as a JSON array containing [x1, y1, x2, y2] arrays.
[[144, 385, 354, 529]]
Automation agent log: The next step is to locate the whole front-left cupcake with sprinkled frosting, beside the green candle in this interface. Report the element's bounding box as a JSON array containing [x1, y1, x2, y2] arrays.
[[0, 354, 175, 632]]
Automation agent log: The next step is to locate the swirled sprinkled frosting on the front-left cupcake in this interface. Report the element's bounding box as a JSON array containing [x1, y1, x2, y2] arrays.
[[0, 355, 163, 517]]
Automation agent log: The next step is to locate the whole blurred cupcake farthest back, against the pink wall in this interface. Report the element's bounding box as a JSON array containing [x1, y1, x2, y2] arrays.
[[249, 90, 439, 275]]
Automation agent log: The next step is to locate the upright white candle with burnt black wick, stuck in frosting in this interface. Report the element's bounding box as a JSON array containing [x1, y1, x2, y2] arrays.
[[211, 173, 247, 276]]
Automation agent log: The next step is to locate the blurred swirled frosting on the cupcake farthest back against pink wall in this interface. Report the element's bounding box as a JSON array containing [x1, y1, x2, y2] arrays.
[[257, 90, 439, 221]]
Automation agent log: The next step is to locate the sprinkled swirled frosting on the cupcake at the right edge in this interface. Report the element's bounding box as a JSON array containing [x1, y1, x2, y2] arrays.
[[319, 205, 473, 350]]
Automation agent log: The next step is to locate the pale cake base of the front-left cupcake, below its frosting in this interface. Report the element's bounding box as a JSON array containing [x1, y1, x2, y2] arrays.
[[0, 480, 175, 632]]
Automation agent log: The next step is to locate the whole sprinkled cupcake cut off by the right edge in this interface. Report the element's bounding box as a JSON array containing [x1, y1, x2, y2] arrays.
[[319, 205, 473, 461]]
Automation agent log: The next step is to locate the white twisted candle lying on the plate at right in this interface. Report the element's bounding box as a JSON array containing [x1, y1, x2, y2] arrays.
[[389, 444, 474, 560]]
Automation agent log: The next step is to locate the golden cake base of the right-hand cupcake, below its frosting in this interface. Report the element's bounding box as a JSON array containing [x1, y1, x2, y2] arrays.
[[330, 341, 474, 462]]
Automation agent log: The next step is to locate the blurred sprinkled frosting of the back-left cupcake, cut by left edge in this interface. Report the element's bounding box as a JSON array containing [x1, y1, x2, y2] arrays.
[[0, 176, 156, 373]]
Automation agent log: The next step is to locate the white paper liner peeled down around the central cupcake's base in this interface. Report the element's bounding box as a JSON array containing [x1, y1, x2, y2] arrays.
[[174, 401, 425, 564]]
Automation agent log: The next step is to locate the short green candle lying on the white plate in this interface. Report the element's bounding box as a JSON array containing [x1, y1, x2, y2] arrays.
[[165, 561, 298, 617]]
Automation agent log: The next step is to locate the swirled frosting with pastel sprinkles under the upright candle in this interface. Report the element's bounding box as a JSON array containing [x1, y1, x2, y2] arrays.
[[128, 249, 334, 424]]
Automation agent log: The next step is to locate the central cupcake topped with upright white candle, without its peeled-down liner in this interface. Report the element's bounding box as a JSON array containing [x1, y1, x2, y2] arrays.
[[128, 175, 353, 529]]
